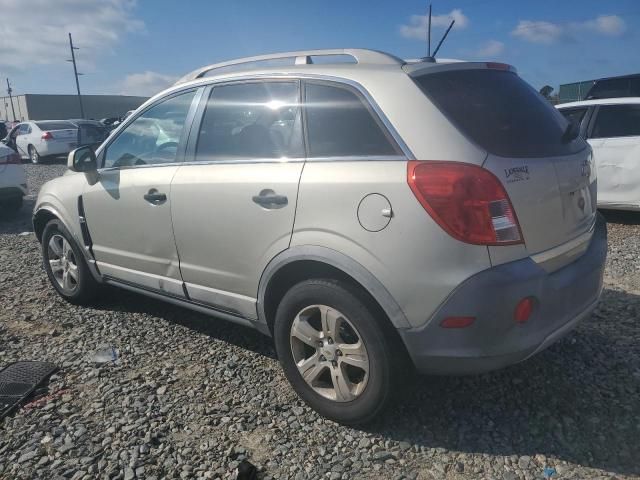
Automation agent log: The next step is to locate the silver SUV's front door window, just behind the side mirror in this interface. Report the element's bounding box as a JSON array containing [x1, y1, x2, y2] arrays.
[[103, 91, 195, 167]]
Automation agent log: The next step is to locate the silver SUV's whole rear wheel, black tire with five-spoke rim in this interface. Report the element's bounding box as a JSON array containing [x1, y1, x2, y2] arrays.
[[274, 279, 400, 425]]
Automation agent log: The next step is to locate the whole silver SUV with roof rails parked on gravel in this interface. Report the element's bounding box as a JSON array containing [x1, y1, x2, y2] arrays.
[[34, 50, 606, 423]]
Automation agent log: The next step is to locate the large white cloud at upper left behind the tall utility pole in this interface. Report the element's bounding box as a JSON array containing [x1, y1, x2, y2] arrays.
[[0, 0, 144, 71]]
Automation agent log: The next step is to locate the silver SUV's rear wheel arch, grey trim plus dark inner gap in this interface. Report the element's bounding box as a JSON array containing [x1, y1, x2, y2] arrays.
[[257, 246, 410, 334]]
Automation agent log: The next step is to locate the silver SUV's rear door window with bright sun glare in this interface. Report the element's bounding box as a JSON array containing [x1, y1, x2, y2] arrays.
[[196, 82, 302, 162]]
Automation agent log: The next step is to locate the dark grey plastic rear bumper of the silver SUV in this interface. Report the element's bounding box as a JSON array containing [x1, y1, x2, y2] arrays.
[[400, 215, 607, 375]]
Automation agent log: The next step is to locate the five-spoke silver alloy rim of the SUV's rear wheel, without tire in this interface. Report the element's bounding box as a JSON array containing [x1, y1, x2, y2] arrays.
[[290, 305, 369, 402]]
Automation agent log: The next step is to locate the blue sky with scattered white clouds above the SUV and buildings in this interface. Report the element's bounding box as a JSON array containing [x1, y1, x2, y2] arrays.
[[0, 0, 640, 96]]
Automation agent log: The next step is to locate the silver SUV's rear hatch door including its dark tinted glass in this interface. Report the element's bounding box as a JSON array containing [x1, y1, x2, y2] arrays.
[[414, 63, 596, 255]]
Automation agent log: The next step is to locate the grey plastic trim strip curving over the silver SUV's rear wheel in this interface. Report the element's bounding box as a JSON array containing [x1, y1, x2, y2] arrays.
[[257, 245, 410, 333]]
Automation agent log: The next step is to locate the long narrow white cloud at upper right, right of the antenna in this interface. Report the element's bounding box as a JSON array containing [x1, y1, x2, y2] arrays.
[[511, 15, 627, 45]]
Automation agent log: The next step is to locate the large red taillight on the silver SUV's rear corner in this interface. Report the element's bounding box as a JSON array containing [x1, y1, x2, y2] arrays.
[[407, 160, 523, 245]]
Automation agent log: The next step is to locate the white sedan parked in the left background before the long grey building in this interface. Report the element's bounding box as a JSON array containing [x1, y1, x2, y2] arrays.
[[7, 120, 78, 163]]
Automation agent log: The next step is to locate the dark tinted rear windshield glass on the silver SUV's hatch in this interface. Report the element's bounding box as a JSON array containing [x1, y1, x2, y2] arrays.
[[415, 69, 585, 157]]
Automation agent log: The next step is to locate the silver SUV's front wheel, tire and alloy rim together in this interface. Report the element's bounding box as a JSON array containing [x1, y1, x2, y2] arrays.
[[42, 220, 99, 305]]
